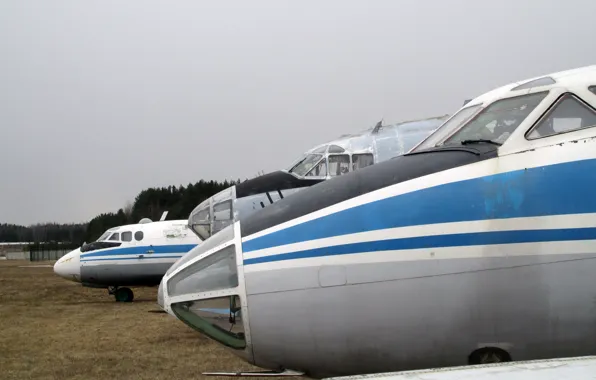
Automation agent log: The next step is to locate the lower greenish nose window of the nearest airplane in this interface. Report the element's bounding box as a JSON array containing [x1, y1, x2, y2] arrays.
[[172, 295, 246, 350]]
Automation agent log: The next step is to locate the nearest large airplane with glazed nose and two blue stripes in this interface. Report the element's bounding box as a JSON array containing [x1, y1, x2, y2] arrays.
[[160, 65, 596, 378]]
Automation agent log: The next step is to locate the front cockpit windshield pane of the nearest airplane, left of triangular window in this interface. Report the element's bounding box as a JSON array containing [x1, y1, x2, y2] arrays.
[[443, 91, 548, 145]]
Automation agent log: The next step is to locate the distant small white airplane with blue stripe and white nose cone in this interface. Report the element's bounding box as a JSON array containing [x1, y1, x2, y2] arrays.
[[54, 211, 201, 302]]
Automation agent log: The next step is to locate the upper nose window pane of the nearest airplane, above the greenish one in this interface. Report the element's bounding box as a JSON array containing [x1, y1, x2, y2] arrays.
[[168, 244, 238, 297]]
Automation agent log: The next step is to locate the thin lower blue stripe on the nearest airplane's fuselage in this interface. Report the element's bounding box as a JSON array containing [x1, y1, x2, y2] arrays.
[[244, 228, 596, 265]]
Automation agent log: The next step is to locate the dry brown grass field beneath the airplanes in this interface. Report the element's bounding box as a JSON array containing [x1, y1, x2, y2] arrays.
[[0, 260, 266, 380]]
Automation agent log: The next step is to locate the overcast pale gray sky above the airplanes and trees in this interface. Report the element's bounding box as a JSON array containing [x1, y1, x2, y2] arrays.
[[0, 0, 596, 224]]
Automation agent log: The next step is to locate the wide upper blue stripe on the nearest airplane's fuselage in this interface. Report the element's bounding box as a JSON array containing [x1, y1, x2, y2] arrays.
[[242, 157, 596, 252]]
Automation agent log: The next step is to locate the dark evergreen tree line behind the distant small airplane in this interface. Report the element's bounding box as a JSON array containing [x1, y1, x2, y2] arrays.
[[0, 180, 240, 245]]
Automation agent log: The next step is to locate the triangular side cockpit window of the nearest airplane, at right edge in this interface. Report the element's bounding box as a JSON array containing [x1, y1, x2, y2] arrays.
[[528, 94, 596, 139]]
